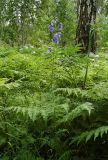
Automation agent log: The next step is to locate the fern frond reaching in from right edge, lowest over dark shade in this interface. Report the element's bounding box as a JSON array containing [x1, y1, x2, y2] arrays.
[[70, 126, 108, 144]]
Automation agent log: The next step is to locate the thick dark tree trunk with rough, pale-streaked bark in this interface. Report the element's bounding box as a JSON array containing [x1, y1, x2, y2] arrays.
[[76, 0, 96, 53]]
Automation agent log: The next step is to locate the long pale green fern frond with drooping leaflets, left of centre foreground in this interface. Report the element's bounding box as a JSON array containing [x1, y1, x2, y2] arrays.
[[7, 102, 68, 122]]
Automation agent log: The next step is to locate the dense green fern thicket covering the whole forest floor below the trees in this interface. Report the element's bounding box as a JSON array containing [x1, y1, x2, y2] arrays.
[[0, 45, 108, 160]]
